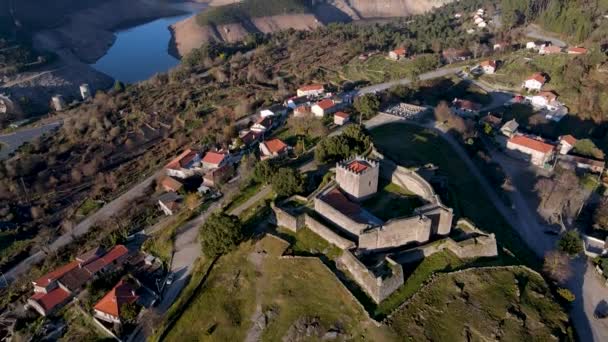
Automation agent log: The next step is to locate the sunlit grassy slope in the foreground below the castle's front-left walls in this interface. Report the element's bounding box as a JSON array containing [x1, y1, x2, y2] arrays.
[[166, 237, 394, 341]]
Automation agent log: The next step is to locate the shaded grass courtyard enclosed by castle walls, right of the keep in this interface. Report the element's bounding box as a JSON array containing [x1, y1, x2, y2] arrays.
[[363, 183, 423, 221]]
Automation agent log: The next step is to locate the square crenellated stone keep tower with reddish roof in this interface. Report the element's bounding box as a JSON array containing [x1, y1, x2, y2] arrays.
[[336, 156, 380, 200]]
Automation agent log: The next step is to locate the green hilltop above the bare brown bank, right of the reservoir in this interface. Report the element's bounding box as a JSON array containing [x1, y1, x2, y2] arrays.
[[196, 0, 309, 26]]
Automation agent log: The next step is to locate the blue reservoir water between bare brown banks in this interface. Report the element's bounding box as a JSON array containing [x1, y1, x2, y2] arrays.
[[92, 4, 204, 83]]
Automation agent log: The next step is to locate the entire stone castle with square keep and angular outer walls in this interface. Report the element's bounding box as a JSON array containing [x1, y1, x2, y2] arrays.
[[272, 153, 497, 303]]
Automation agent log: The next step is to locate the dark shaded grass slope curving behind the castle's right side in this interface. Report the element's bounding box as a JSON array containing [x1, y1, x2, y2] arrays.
[[371, 123, 540, 269]]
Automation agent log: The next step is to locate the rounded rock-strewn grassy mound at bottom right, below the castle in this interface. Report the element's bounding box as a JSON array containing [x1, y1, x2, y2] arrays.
[[390, 267, 571, 341]]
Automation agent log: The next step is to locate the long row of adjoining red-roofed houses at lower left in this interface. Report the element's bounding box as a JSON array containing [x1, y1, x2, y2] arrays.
[[25, 245, 129, 316]]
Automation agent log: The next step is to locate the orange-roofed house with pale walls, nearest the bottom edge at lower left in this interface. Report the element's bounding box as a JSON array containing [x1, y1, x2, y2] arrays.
[[93, 280, 139, 324]]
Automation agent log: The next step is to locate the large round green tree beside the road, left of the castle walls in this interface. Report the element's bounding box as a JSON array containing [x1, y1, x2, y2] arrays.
[[200, 212, 243, 258]]
